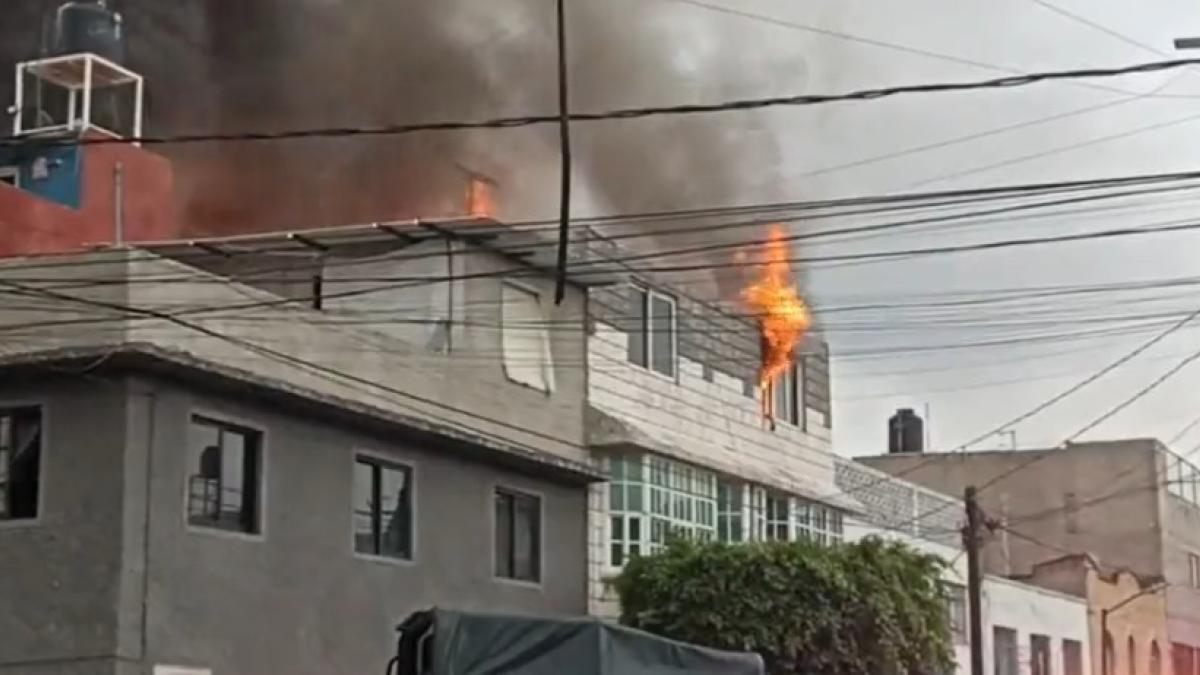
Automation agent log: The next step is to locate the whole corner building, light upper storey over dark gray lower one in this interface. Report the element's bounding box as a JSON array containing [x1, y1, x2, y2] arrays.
[[0, 216, 619, 675]]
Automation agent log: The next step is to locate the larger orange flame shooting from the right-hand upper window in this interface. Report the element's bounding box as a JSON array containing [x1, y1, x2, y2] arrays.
[[742, 225, 811, 418]]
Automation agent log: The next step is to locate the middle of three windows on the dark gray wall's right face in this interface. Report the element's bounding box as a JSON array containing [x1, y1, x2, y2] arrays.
[[354, 456, 413, 560]]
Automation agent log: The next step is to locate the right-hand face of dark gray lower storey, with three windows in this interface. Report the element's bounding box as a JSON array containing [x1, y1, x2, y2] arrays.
[[121, 372, 587, 675]]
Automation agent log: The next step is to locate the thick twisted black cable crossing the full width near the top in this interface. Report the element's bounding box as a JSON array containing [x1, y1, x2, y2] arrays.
[[9, 59, 1200, 147]]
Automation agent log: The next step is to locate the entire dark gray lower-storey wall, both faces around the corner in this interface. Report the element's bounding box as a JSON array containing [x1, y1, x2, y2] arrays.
[[0, 369, 587, 675]]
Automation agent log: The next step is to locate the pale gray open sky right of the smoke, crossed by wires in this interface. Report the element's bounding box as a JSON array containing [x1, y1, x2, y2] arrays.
[[666, 0, 1200, 455]]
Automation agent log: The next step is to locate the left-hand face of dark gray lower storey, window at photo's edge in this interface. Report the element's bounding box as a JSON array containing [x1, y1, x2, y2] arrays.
[[0, 376, 126, 675]]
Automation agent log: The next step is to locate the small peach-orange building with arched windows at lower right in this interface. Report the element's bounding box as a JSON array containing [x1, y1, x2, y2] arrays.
[[1026, 554, 1166, 675]]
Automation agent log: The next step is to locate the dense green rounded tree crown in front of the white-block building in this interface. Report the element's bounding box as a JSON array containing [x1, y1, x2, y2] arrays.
[[617, 538, 953, 675]]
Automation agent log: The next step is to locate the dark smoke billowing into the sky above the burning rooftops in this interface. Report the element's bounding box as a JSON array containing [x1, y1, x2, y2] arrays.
[[7, 0, 804, 291]]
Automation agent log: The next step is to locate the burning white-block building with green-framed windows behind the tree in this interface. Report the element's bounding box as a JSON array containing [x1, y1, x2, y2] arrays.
[[588, 234, 858, 616]]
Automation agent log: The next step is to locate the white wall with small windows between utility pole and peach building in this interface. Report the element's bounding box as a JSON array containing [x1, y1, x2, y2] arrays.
[[983, 575, 1093, 675]]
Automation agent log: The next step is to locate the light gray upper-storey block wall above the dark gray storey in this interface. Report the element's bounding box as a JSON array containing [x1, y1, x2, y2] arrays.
[[0, 251, 588, 464]]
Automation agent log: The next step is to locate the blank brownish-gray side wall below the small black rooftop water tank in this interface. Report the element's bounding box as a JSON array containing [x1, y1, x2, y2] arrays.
[[859, 440, 1163, 575]]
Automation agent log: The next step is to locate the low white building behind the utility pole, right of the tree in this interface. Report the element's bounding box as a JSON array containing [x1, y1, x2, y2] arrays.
[[836, 458, 1094, 675]]
